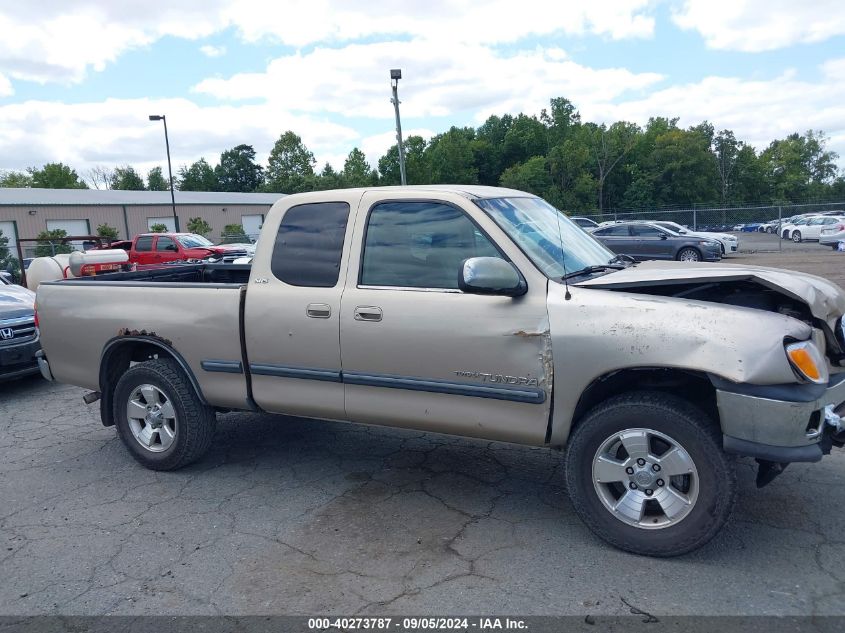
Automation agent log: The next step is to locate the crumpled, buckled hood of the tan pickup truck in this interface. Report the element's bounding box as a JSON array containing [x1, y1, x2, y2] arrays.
[[573, 261, 845, 328]]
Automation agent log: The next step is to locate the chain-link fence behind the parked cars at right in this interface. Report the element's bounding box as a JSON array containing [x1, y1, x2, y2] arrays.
[[570, 202, 845, 252]]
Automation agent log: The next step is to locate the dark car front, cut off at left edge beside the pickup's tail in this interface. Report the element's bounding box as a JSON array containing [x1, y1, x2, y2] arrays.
[[0, 275, 41, 380]]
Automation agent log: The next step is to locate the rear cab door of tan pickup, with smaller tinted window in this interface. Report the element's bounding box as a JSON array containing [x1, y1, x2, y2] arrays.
[[244, 191, 361, 419]]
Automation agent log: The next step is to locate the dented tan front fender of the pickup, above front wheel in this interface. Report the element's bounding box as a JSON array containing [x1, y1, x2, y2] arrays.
[[548, 283, 813, 446]]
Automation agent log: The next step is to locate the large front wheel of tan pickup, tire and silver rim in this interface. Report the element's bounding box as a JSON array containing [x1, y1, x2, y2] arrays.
[[566, 392, 736, 556]]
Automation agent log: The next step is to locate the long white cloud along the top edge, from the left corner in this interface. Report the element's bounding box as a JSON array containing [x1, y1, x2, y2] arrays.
[[0, 0, 654, 83]]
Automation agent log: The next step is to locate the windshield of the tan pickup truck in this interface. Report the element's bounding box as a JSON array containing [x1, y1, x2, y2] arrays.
[[475, 198, 615, 277]]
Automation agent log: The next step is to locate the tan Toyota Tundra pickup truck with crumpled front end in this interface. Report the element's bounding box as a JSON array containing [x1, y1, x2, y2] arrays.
[[37, 186, 845, 556]]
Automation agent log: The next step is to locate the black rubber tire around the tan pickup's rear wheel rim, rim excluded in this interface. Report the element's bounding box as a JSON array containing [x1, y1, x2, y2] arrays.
[[113, 359, 217, 470]]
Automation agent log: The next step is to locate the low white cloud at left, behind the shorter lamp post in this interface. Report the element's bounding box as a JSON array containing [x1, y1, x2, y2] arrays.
[[0, 99, 359, 174]]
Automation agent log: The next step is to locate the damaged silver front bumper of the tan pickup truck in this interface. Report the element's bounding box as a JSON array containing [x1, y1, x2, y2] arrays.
[[713, 374, 845, 463]]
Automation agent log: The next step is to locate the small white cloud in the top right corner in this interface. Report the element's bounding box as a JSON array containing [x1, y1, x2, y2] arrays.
[[673, 0, 845, 52]]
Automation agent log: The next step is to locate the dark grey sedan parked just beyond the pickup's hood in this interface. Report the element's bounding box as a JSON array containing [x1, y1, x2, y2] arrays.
[[592, 221, 722, 262]]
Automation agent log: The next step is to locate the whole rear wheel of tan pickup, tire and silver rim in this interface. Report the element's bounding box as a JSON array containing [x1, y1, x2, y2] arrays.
[[114, 359, 216, 470]]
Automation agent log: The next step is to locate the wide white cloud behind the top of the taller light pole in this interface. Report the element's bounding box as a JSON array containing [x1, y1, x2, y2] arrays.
[[194, 40, 662, 118]]
